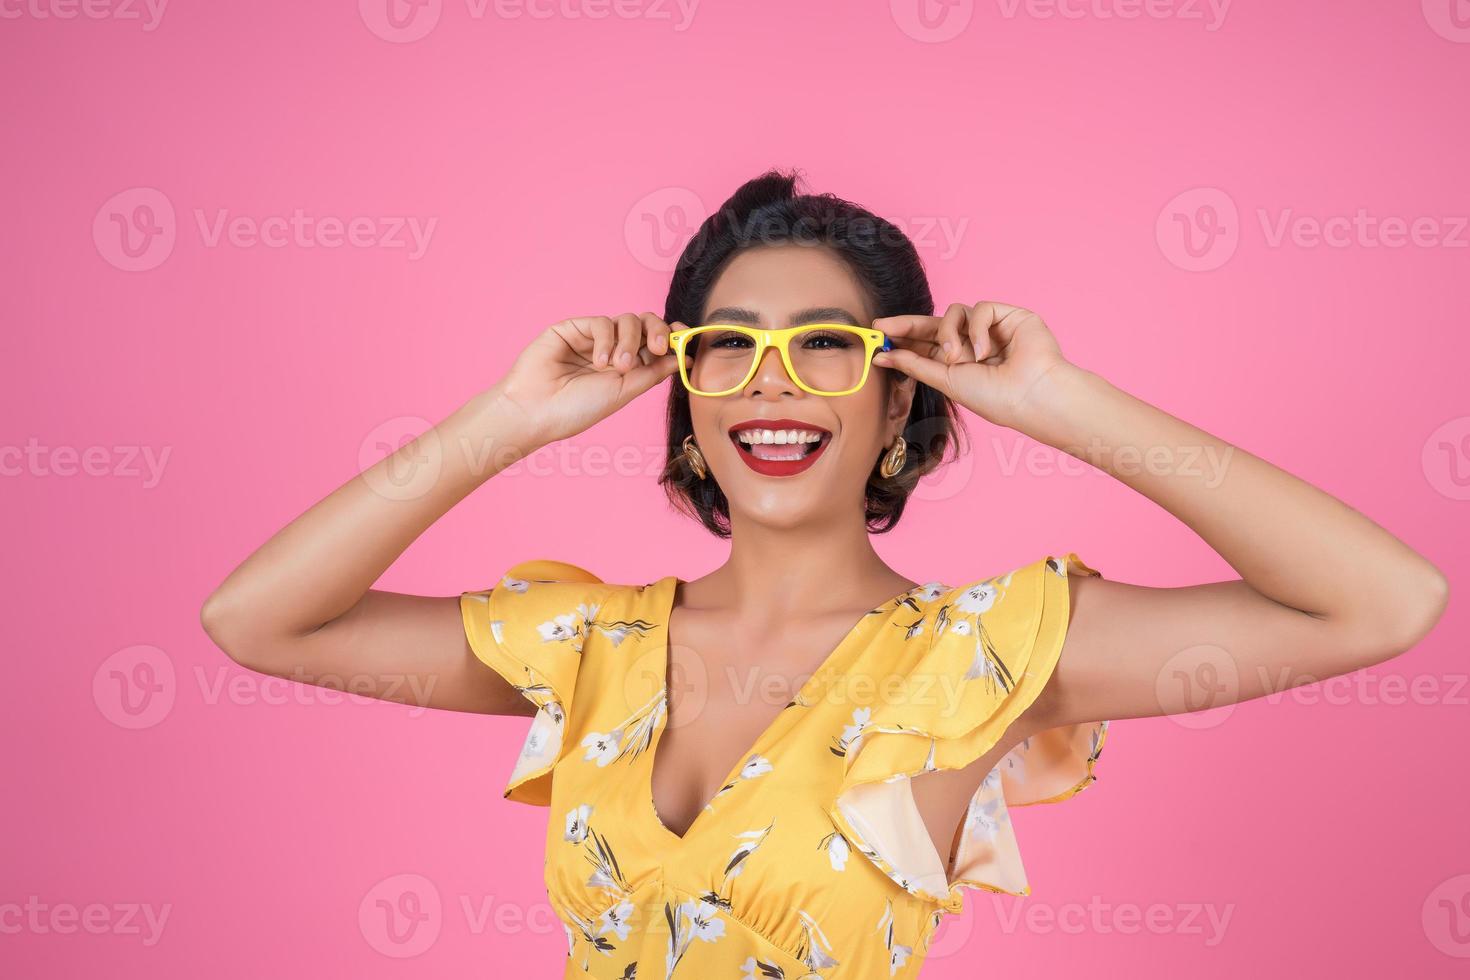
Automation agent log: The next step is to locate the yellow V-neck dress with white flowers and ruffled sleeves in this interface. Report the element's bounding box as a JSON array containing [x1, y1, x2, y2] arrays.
[[460, 552, 1107, 980]]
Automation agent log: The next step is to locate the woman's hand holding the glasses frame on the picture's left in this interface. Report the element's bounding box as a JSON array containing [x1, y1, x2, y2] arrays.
[[491, 313, 684, 445]]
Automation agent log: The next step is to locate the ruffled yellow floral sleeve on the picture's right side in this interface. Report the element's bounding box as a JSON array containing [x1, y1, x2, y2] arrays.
[[831, 552, 1107, 911]]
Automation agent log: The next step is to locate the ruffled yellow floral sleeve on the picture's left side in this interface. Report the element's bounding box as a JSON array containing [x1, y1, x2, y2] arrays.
[[460, 560, 601, 807]]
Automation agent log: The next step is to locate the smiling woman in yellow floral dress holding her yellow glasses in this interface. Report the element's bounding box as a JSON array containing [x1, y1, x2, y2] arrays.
[[203, 172, 1448, 980]]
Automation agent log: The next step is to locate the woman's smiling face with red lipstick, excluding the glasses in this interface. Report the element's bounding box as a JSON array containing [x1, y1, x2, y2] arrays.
[[689, 244, 914, 526]]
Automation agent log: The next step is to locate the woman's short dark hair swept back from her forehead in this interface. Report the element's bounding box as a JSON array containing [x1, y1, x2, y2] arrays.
[[659, 170, 963, 538]]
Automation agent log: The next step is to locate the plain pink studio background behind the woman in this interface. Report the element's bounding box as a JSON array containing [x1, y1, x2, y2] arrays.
[[0, 0, 1470, 980]]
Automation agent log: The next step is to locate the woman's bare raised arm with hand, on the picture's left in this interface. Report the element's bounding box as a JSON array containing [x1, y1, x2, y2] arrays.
[[200, 313, 676, 714]]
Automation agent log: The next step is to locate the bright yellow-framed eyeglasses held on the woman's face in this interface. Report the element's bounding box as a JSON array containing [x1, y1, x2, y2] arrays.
[[669, 323, 894, 397]]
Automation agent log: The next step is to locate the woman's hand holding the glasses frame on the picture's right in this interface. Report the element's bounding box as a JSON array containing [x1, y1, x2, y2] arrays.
[[873, 303, 1070, 429]]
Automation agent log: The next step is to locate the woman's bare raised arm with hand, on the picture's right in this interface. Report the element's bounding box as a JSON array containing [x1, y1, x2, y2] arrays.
[[875, 303, 1448, 733]]
